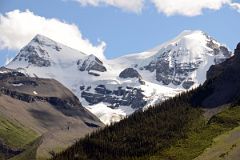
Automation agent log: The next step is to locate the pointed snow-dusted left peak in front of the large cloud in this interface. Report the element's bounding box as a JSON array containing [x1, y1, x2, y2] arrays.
[[8, 34, 86, 68]]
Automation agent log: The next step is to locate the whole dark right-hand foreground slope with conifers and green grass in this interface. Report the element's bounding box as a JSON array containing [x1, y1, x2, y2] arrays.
[[53, 42, 240, 160]]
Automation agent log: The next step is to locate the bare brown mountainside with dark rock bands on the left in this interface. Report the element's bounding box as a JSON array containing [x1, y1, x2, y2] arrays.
[[0, 68, 103, 159]]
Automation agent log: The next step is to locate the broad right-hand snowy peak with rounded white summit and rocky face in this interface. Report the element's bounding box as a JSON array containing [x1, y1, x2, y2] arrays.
[[115, 30, 232, 89]]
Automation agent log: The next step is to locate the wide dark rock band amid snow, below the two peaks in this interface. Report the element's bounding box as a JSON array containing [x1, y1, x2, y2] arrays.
[[81, 85, 147, 109]]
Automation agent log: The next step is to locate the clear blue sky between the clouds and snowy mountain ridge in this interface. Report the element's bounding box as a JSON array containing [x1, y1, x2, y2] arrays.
[[0, 0, 240, 65]]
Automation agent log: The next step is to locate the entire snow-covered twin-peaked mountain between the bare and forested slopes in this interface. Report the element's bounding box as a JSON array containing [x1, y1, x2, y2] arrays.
[[6, 31, 232, 124]]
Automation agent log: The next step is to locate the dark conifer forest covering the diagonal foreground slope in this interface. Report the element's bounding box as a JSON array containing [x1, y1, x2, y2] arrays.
[[54, 91, 201, 160]]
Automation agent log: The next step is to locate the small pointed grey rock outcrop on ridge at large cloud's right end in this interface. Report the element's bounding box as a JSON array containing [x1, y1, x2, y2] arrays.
[[77, 55, 107, 72]]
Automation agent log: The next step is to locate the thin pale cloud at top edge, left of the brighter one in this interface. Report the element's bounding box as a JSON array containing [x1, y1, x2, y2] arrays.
[[75, 0, 144, 13]]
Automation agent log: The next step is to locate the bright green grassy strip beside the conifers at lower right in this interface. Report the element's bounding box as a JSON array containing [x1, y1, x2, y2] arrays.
[[152, 106, 240, 160]]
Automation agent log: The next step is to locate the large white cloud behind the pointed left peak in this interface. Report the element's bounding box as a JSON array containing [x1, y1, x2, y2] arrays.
[[0, 10, 105, 58]]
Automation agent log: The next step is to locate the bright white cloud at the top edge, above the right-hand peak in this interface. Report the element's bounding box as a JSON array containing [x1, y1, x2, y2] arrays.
[[151, 0, 231, 16]]
